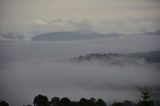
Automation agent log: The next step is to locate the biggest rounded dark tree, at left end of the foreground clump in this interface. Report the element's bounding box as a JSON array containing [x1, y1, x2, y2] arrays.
[[33, 95, 49, 106]]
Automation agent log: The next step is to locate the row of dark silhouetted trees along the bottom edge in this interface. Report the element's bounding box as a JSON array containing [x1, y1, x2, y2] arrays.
[[0, 91, 160, 106]]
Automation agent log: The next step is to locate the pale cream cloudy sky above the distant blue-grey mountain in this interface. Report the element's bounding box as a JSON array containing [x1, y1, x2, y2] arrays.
[[0, 0, 160, 38]]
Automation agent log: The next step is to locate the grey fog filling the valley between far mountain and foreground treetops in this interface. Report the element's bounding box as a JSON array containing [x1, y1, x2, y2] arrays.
[[0, 35, 160, 105]]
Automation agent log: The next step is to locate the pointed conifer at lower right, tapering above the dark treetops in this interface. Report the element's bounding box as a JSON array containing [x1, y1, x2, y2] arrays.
[[137, 89, 154, 106]]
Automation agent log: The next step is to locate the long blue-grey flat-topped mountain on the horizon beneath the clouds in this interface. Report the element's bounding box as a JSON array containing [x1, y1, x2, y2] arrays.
[[31, 32, 119, 41]]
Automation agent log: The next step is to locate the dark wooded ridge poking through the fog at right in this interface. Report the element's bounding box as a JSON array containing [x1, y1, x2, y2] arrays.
[[70, 50, 160, 63]]
